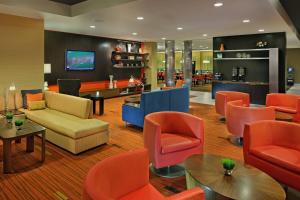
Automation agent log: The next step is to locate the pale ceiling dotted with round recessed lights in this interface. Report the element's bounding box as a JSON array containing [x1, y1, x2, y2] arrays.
[[0, 0, 300, 49]]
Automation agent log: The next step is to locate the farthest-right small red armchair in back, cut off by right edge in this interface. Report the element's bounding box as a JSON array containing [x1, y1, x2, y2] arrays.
[[266, 93, 300, 122]]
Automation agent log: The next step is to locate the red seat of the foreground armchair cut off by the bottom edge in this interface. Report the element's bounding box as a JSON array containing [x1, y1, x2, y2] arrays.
[[120, 184, 165, 200]]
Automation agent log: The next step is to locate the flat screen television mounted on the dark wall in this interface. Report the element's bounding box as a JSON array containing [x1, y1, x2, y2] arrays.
[[65, 50, 95, 71]]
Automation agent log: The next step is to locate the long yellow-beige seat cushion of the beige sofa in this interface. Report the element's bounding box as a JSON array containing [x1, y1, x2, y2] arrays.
[[22, 108, 108, 139]]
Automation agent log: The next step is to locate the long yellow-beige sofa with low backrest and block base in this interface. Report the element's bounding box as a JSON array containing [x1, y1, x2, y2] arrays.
[[0, 91, 109, 154]]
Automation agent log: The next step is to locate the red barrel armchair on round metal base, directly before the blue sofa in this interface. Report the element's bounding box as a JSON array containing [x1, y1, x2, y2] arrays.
[[144, 112, 204, 177]]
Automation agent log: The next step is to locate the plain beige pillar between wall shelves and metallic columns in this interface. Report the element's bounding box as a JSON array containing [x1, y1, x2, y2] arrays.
[[144, 42, 158, 89]]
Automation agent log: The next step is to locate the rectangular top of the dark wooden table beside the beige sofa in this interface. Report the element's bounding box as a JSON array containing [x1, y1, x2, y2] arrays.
[[0, 118, 45, 140]]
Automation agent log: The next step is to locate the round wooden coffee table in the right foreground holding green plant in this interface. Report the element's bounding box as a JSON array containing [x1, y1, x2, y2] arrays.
[[185, 154, 286, 200]]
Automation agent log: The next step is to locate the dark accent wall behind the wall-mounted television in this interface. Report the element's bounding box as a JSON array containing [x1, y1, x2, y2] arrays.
[[45, 31, 141, 85]]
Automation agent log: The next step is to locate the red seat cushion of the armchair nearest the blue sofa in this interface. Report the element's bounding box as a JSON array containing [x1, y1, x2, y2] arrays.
[[161, 133, 200, 154]]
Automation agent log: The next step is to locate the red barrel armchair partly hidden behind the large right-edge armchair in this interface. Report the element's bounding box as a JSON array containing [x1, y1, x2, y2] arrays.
[[226, 100, 275, 143]]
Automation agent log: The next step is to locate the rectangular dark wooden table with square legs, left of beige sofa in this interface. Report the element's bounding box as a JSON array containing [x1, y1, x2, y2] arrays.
[[0, 118, 46, 173]]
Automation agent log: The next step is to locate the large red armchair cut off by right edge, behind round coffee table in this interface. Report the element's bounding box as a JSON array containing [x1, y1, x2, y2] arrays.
[[244, 120, 300, 190]]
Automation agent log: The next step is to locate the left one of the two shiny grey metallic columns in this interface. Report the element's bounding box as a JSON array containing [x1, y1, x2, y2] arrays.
[[165, 40, 175, 86]]
